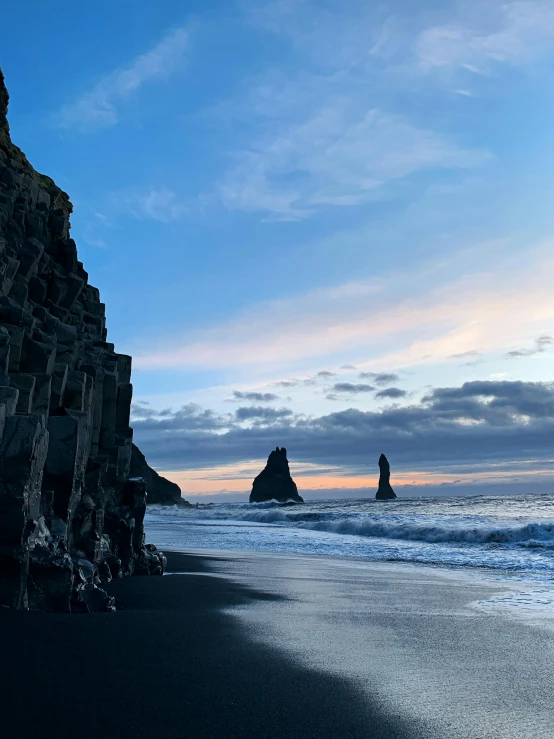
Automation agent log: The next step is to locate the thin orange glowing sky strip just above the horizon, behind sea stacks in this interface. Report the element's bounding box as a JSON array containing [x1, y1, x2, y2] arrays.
[[154, 462, 553, 495]]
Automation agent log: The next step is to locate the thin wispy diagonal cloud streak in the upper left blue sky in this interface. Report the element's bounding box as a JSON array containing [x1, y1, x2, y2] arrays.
[[54, 28, 189, 132]]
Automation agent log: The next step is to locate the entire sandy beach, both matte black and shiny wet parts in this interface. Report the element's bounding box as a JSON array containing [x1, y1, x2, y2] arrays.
[[0, 552, 554, 739]]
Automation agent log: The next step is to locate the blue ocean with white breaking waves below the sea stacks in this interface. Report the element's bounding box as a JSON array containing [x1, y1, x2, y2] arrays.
[[146, 494, 554, 585]]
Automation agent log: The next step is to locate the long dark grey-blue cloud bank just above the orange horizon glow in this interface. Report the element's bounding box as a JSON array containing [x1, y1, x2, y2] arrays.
[[133, 381, 554, 481]]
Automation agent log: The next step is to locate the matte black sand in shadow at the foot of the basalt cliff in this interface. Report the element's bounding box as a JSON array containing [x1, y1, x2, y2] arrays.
[[0, 554, 423, 739]]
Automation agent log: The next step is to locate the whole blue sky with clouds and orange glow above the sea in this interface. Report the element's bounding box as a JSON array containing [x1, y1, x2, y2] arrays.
[[0, 0, 554, 501]]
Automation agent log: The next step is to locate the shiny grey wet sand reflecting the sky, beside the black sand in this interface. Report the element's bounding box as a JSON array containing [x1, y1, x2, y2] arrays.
[[166, 550, 554, 739]]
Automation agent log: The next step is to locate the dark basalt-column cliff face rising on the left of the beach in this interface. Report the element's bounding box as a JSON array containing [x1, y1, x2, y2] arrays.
[[0, 72, 165, 612]]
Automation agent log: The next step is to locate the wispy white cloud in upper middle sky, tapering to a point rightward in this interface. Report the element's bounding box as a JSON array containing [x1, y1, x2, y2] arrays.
[[219, 105, 488, 221]]
